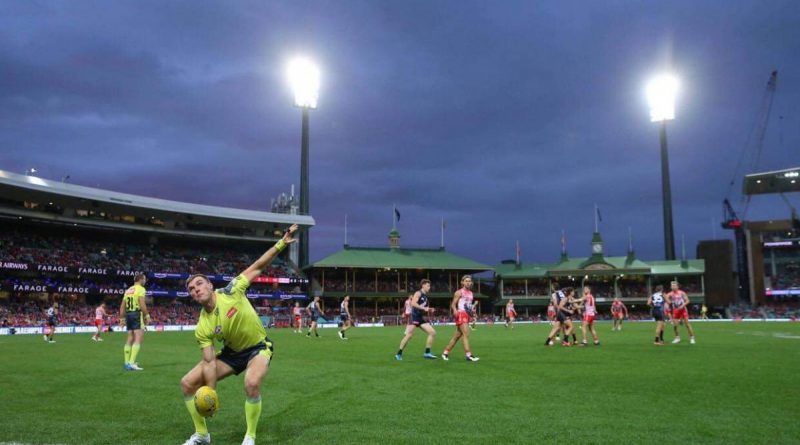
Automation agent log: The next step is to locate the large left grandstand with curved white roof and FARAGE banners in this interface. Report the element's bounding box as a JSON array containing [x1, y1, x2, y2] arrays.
[[0, 171, 314, 326]]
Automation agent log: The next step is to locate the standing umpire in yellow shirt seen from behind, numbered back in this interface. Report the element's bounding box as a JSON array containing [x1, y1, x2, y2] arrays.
[[119, 273, 150, 371]]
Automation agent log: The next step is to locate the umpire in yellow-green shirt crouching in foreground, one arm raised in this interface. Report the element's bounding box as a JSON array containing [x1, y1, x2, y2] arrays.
[[181, 224, 297, 445]]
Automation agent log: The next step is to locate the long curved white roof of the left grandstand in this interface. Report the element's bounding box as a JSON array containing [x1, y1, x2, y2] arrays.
[[0, 170, 315, 226]]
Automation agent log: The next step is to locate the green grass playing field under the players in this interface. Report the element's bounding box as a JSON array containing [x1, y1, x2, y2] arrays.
[[0, 323, 800, 445]]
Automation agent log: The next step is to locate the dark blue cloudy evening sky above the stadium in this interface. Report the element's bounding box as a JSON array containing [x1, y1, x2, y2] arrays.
[[0, 0, 800, 264]]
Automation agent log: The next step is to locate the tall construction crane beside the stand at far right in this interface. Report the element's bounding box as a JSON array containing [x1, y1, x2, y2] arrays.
[[722, 70, 778, 301]]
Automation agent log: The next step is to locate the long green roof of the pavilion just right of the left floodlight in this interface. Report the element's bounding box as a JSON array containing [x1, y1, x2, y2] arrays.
[[313, 246, 492, 272]]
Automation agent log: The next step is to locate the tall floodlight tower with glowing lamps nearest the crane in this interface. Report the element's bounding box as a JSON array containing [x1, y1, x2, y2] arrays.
[[647, 74, 679, 260]]
